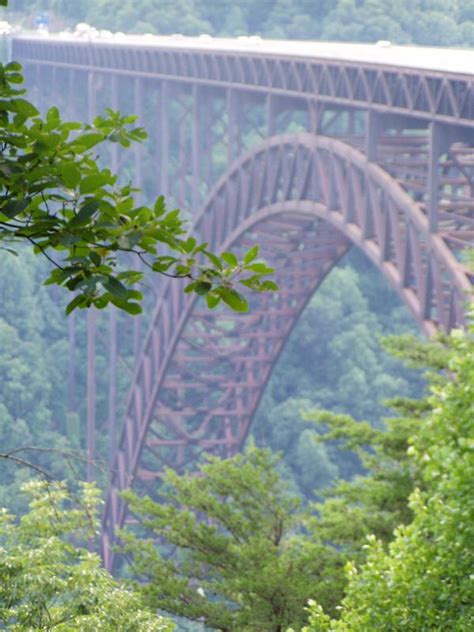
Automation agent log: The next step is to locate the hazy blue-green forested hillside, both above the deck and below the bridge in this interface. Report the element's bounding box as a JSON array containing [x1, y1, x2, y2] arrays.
[[0, 0, 424, 505]]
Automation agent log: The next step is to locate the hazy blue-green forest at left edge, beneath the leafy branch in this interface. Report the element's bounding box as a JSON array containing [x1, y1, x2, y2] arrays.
[[0, 249, 81, 513]]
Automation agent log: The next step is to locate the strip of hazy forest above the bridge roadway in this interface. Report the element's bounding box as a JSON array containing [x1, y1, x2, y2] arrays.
[[7, 0, 474, 46]]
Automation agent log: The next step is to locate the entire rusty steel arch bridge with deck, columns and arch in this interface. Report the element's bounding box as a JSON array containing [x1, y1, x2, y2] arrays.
[[13, 32, 474, 568]]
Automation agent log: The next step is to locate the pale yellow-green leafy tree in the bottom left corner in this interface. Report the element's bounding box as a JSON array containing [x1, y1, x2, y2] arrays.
[[0, 482, 173, 632]]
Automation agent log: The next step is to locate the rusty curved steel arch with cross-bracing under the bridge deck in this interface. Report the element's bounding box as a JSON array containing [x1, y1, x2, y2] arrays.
[[102, 133, 470, 568]]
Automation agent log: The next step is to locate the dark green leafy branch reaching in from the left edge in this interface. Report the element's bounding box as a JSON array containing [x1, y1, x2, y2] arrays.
[[0, 62, 277, 314]]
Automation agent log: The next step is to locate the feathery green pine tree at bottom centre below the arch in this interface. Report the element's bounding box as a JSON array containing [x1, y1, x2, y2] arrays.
[[120, 448, 338, 632]]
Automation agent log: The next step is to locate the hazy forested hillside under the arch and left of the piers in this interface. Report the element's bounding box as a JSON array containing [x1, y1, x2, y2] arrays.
[[0, 244, 422, 511]]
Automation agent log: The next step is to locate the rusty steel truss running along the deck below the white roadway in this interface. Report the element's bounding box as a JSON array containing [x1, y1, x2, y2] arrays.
[[13, 36, 474, 127]]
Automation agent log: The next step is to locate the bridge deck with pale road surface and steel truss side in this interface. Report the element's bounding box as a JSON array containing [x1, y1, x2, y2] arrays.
[[13, 34, 474, 125]]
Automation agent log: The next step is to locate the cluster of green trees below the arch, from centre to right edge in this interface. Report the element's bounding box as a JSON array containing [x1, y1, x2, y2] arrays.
[[118, 324, 474, 632]]
